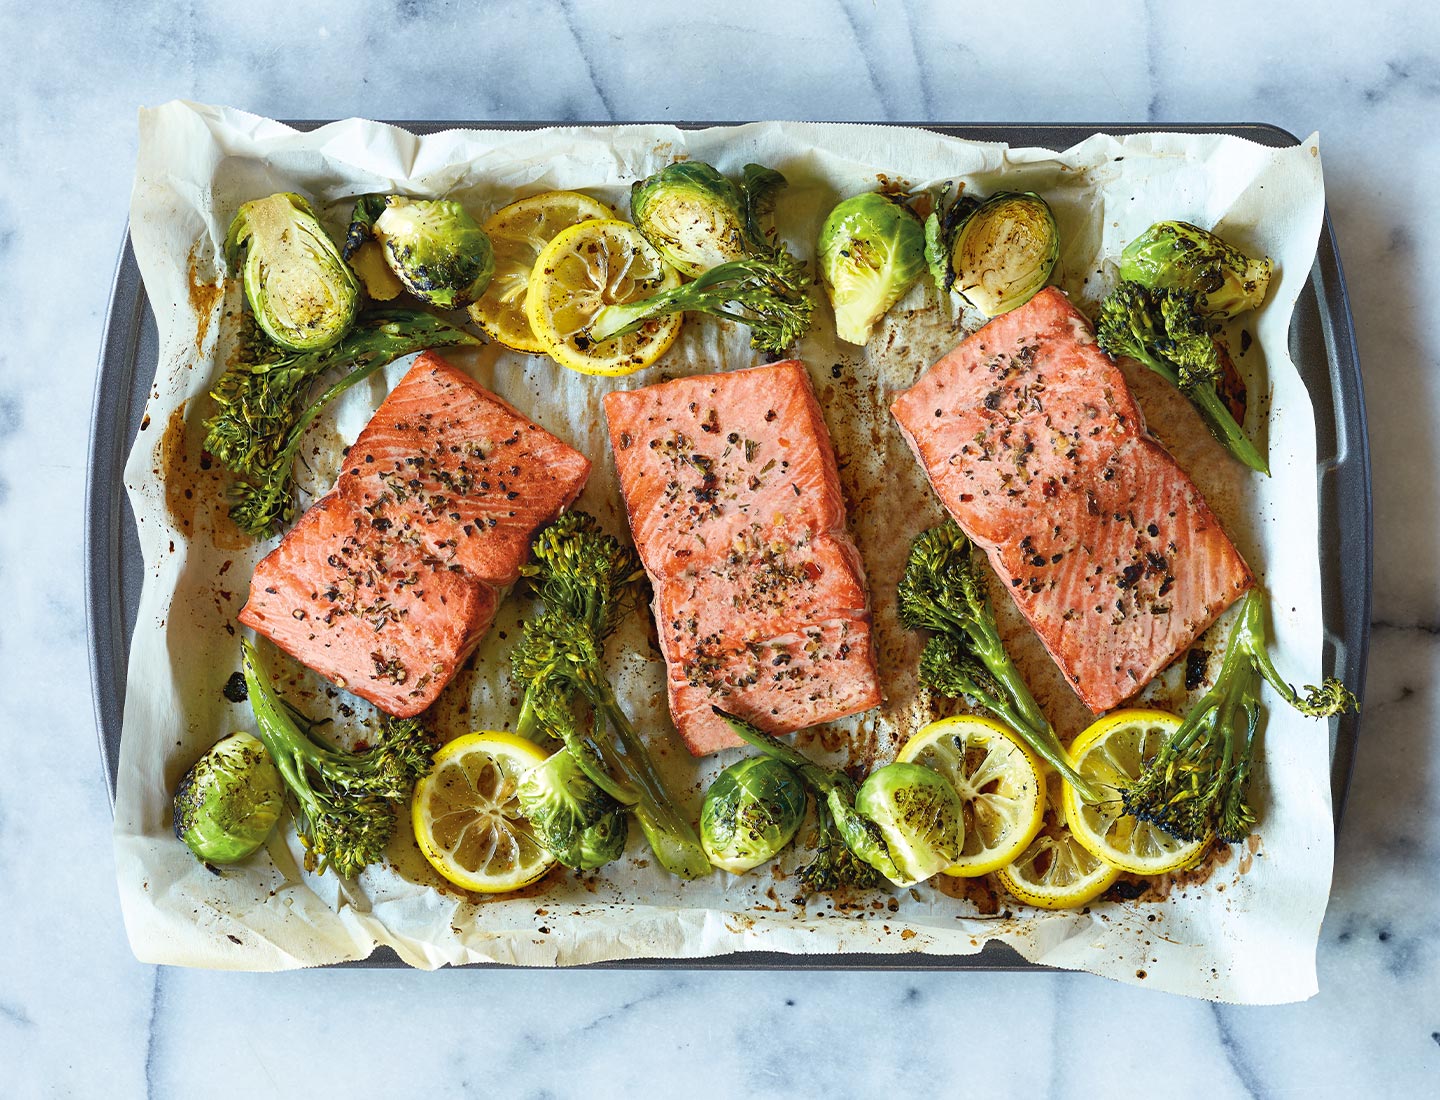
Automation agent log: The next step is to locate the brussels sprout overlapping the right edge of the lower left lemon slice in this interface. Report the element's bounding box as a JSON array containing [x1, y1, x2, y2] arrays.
[[518, 749, 628, 871]]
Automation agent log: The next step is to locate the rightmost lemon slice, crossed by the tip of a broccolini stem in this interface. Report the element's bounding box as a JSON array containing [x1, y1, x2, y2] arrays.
[[1063, 708, 1210, 874]]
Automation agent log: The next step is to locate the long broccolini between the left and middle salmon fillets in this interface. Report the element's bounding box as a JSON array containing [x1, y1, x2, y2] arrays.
[[511, 511, 711, 878]]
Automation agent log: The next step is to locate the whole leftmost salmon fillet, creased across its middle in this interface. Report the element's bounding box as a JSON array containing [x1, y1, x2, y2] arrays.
[[239, 353, 590, 717]]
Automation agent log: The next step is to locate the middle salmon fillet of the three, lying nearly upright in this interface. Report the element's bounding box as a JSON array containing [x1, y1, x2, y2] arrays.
[[605, 360, 880, 756]]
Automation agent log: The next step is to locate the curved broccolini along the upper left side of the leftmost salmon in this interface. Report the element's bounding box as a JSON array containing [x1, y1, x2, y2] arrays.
[[204, 310, 481, 538]]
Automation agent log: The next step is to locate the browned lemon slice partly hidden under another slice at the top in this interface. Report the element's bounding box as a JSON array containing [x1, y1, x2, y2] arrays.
[[469, 191, 615, 351]]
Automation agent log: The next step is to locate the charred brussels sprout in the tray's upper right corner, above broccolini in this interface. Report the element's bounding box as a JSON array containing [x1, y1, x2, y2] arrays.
[[1120, 222, 1274, 318]]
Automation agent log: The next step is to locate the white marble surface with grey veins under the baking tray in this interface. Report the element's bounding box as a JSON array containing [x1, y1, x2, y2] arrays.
[[0, 0, 1440, 1097]]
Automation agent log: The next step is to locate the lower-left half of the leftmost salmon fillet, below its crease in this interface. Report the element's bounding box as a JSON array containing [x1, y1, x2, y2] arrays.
[[240, 492, 495, 717]]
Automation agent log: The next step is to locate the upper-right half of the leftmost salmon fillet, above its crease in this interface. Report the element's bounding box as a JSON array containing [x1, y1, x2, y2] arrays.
[[338, 353, 590, 587]]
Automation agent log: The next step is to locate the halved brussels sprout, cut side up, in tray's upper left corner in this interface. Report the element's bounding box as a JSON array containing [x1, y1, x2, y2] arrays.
[[225, 191, 360, 351]]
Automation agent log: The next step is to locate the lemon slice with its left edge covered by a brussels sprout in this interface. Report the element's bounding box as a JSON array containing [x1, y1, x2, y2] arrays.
[[896, 714, 1045, 878]]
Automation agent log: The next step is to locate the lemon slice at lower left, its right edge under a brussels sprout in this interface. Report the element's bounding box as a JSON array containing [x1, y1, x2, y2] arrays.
[[410, 733, 554, 894]]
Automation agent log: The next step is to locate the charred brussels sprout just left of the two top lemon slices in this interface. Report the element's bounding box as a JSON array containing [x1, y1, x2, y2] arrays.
[[368, 194, 495, 310]]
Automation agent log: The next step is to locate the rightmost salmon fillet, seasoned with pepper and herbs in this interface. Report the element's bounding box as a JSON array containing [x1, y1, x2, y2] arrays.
[[890, 288, 1254, 713]]
